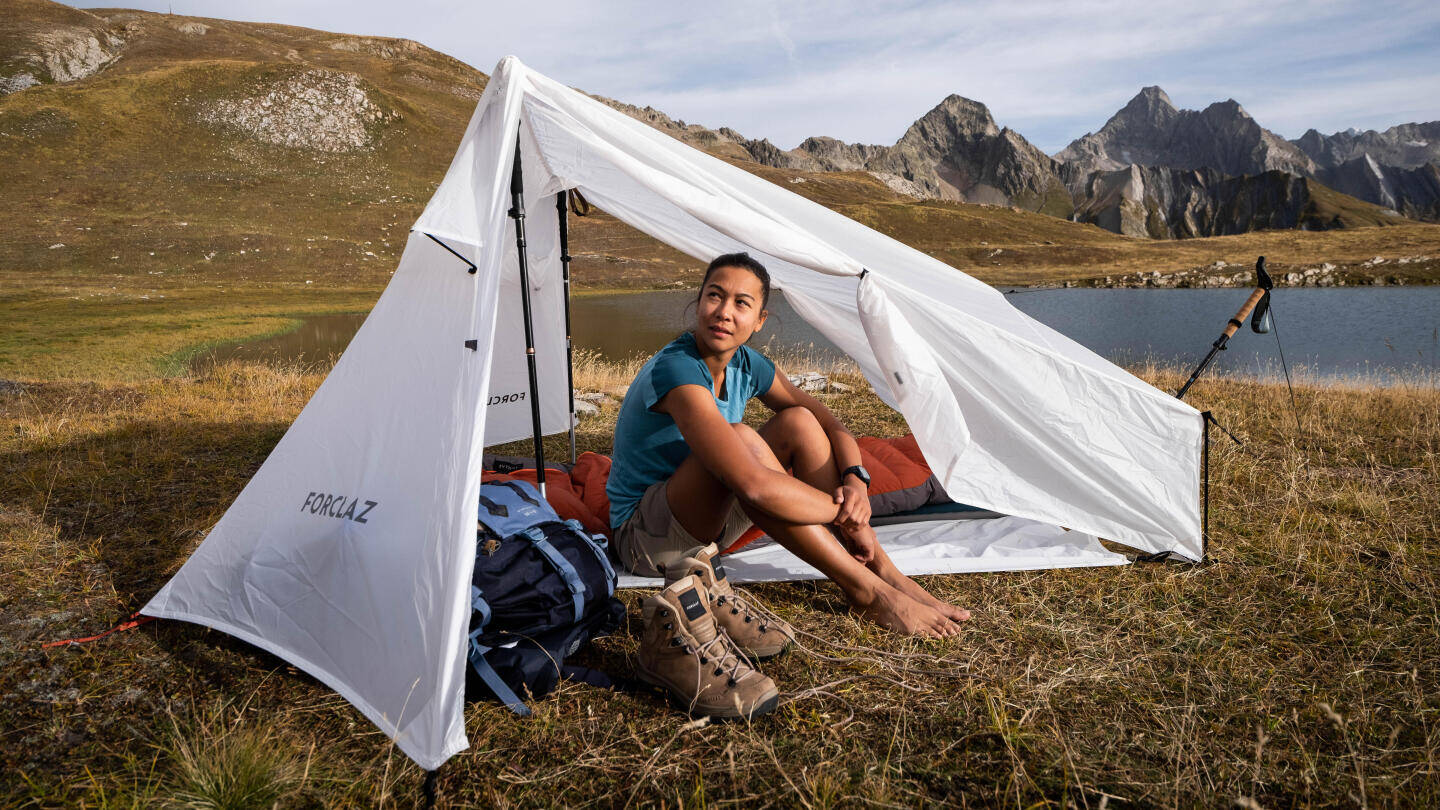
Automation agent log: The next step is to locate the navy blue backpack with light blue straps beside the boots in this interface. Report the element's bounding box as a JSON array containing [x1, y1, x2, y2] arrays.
[[469, 481, 625, 715]]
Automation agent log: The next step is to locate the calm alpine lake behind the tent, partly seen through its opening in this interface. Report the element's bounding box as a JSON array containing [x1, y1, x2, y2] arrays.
[[193, 287, 1440, 388]]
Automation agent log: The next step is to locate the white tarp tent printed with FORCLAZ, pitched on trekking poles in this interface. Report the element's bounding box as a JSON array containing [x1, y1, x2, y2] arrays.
[[141, 58, 1202, 768]]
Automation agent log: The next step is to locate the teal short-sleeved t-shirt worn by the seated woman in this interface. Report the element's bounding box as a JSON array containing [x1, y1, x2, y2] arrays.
[[605, 331, 775, 529]]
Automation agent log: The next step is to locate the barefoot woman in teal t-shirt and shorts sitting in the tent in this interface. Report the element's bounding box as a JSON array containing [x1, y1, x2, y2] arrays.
[[606, 254, 969, 637]]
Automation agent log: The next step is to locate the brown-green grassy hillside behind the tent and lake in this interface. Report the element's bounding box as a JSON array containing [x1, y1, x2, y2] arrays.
[[0, 0, 1440, 379]]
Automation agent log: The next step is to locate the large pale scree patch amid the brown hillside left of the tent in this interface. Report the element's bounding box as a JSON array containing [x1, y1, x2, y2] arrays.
[[200, 69, 399, 153]]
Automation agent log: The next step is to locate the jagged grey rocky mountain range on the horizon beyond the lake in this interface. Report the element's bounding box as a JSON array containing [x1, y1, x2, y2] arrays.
[[603, 78, 1440, 238]]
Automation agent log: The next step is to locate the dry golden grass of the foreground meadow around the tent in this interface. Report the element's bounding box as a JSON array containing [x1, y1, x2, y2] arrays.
[[0, 356, 1440, 807]]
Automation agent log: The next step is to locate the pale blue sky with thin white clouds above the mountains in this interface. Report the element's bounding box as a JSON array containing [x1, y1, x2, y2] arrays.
[[75, 0, 1440, 153]]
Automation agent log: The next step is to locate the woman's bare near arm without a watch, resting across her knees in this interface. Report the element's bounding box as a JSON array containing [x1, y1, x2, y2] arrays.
[[655, 385, 840, 523]]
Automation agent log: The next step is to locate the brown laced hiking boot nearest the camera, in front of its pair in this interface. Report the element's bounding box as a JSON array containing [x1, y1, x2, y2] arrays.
[[638, 577, 780, 719]]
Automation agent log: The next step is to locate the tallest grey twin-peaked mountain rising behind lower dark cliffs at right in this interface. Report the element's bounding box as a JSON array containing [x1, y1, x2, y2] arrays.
[[1056, 86, 1316, 182]]
